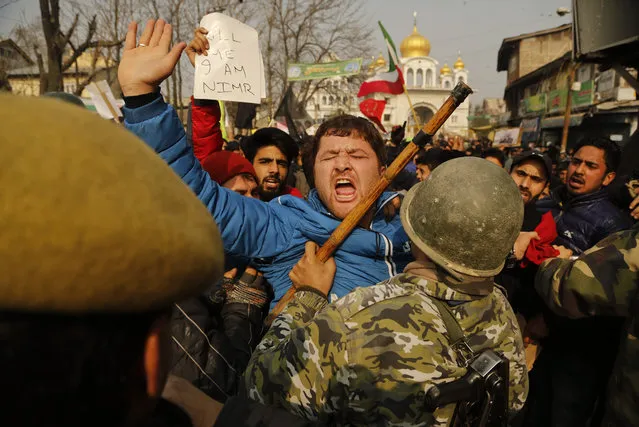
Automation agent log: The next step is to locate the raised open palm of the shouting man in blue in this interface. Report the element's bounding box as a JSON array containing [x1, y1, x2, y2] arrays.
[[118, 19, 186, 96]]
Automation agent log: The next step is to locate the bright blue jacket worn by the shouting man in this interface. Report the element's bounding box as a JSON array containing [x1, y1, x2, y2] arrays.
[[124, 97, 412, 304]]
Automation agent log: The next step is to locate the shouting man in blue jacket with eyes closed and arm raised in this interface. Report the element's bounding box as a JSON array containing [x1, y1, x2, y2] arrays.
[[118, 20, 411, 303]]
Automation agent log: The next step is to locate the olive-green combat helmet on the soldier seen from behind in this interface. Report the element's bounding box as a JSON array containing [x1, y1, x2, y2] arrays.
[[401, 157, 524, 277]]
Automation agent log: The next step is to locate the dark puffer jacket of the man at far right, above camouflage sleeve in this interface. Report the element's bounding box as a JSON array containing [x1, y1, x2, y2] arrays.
[[537, 185, 633, 254]]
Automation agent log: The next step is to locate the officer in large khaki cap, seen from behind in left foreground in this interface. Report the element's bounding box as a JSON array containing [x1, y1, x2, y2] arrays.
[[0, 95, 320, 427]]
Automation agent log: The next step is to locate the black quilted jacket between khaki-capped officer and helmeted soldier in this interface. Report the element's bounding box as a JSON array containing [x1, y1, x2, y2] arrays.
[[171, 295, 268, 402]]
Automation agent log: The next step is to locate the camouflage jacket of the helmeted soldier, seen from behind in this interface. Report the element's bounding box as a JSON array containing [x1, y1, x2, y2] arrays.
[[245, 263, 528, 426]]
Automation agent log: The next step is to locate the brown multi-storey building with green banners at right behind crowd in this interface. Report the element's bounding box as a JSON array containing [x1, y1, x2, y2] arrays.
[[497, 24, 639, 148]]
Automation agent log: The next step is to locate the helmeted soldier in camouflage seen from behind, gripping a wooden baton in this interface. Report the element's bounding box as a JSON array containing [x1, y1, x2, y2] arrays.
[[245, 158, 528, 426]]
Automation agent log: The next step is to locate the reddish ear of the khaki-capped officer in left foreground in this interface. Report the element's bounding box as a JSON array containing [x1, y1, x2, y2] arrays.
[[144, 316, 171, 397]]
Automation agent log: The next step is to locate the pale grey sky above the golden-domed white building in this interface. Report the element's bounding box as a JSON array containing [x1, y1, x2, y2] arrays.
[[0, 0, 572, 103]]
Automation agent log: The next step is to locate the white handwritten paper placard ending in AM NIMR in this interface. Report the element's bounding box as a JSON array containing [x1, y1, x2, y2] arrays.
[[193, 13, 266, 104]]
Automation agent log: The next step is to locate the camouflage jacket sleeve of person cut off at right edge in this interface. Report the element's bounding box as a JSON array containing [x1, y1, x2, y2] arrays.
[[535, 225, 639, 426]]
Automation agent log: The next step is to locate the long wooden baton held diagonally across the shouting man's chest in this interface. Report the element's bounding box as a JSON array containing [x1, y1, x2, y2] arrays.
[[266, 82, 473, 325]]
